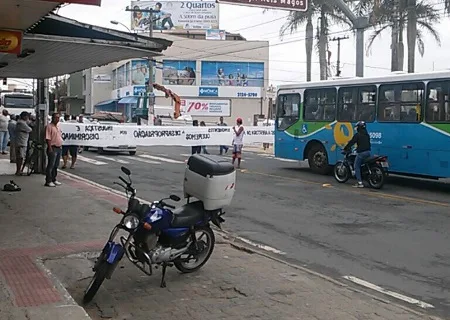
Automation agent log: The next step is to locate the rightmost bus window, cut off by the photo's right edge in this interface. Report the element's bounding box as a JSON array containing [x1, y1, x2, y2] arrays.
[[426, 80, 450, 123]]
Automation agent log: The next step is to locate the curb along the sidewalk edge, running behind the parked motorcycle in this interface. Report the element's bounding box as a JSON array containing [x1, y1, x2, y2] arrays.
[[61, 172, 443, 320]]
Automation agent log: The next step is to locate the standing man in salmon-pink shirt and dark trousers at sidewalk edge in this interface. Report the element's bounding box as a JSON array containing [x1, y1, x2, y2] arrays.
[[45, 112, 63, 187]]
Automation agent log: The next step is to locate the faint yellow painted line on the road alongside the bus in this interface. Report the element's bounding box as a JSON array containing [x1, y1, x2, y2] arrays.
[[241, 170, 450, 208]]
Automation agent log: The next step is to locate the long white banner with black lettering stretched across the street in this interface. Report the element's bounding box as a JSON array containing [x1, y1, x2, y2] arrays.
[[59, 123, 274, 147]]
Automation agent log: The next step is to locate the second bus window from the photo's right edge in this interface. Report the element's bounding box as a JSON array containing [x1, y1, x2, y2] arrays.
[[378, 82, 425, 122]]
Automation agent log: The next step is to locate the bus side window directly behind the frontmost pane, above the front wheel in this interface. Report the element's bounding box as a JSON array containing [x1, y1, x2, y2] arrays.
[[304, 88, 336, 121]]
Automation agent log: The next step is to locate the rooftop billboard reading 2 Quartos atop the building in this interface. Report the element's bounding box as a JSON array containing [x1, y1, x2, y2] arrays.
[[131, 0, 219, 31]]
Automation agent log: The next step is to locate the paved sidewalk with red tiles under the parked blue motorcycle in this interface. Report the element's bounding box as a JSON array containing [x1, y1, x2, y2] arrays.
[[0, 160, 442, 320]]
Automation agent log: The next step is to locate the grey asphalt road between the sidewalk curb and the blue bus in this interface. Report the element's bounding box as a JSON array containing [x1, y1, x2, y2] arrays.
[[63, 147, 450, 316]]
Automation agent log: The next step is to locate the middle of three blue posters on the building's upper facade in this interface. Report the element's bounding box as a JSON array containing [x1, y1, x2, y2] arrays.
[[163, 60, 196, 86]]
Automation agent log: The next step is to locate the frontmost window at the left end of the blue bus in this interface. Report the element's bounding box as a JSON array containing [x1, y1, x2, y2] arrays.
[[277, 93, 300, 130]]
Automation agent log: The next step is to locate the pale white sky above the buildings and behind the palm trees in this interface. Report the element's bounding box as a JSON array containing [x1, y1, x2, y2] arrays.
[[3, 0, 450, 86]]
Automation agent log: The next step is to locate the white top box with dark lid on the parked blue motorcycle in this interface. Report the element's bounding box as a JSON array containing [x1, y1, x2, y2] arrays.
[[183, 154, 236, 210]]
